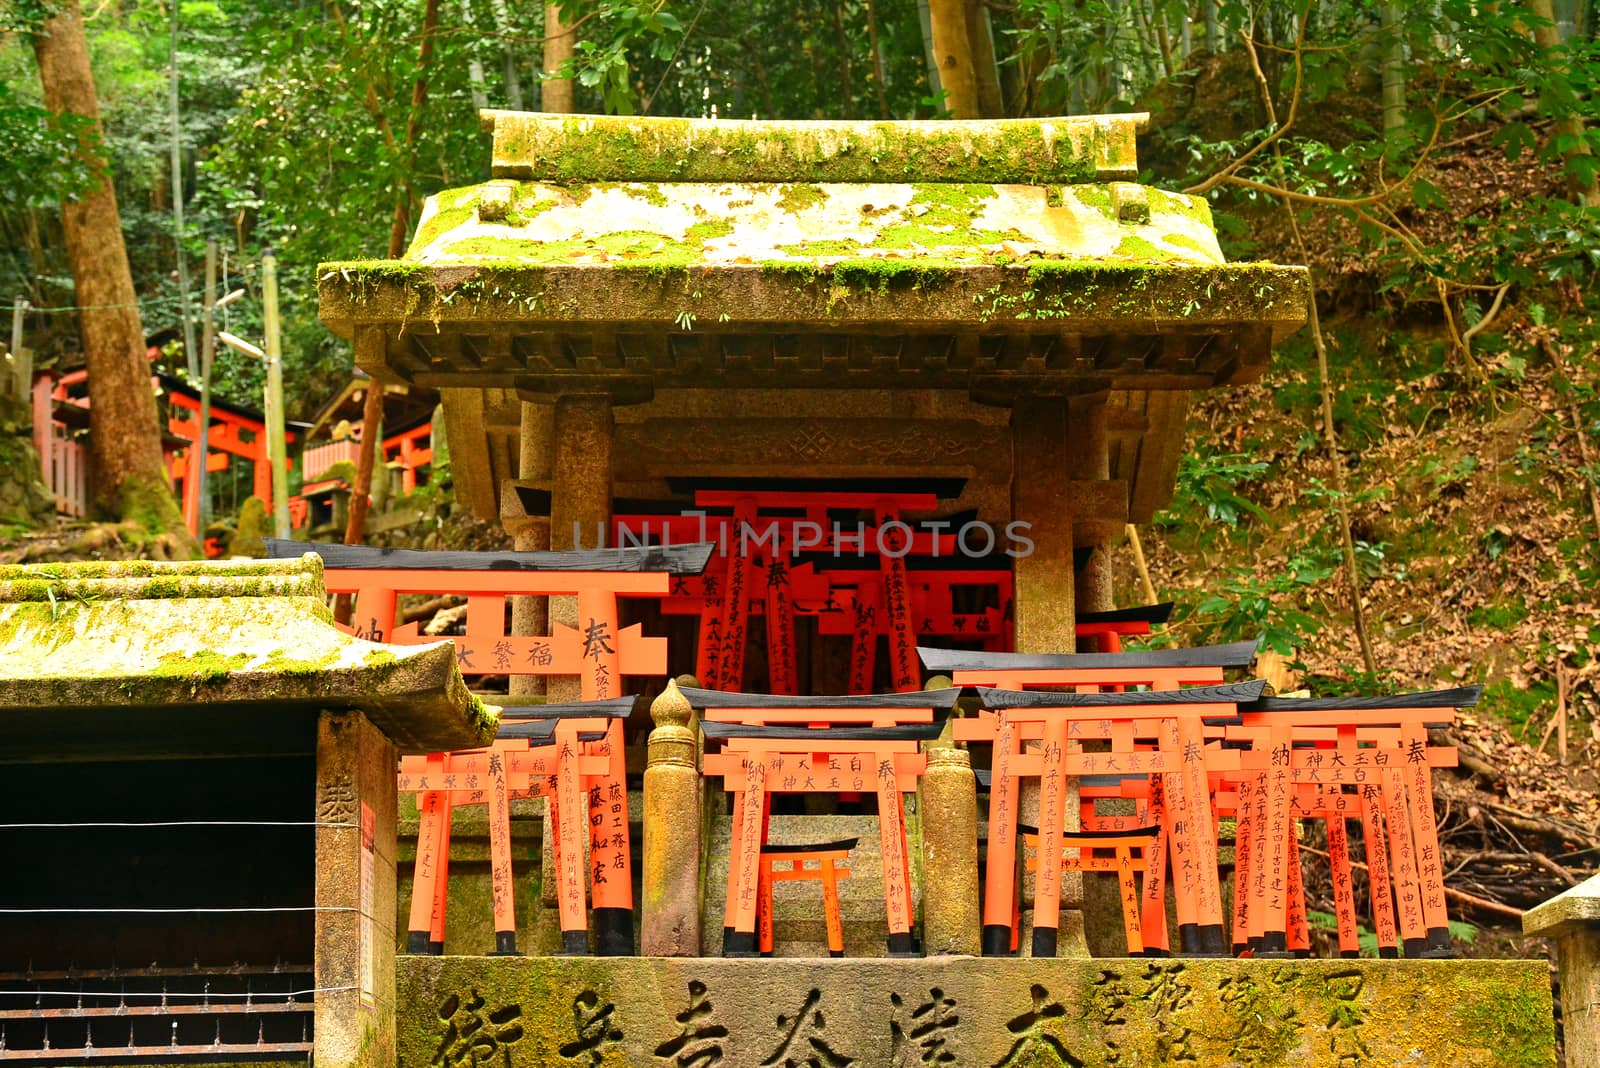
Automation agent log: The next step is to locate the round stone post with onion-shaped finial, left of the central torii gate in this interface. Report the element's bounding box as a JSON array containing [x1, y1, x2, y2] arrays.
[[640, 681, 700, 956]]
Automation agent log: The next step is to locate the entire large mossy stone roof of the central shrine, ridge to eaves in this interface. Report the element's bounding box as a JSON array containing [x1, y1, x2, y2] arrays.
[[318, 112, 1307, 400]]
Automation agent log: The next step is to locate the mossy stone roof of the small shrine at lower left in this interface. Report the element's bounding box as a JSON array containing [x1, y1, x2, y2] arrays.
[[0, 556, 496, 753]]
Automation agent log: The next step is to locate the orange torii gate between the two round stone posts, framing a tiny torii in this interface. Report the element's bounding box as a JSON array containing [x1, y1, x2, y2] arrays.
[[683, 687, 960, 956]]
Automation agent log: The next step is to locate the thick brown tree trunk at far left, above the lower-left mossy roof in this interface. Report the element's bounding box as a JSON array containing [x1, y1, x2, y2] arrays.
[[34, 0, 182, 534]]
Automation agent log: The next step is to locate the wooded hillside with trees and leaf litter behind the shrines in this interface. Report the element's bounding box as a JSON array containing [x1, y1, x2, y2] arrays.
[[0, 0, 1600, 907]]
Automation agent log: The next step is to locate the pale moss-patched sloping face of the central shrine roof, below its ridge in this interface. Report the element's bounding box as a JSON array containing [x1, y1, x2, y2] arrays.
[[396, 181, 1222, 267]]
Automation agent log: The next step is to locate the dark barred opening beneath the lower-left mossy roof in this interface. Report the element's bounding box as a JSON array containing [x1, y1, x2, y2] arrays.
[[0, 713, 317, 1063]]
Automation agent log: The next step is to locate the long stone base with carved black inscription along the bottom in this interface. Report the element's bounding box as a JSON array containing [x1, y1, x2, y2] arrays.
[[395, 956, 1555, 1068]]
